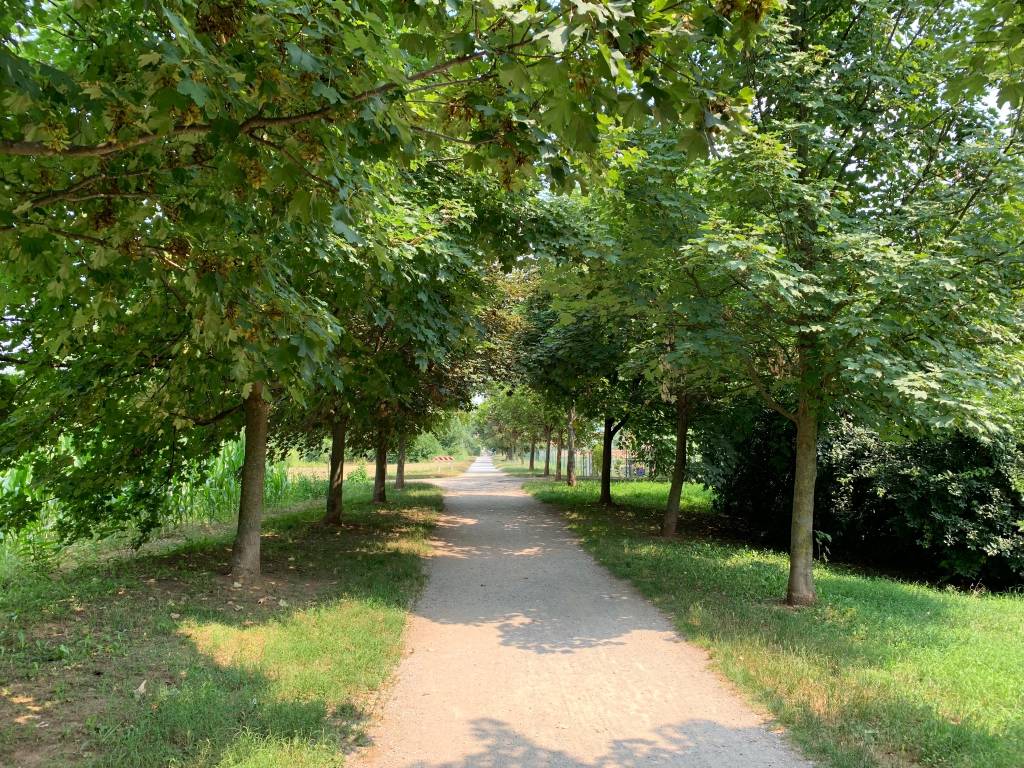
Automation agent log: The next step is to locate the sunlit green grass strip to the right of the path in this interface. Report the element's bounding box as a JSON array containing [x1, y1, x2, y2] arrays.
[[526, 481, 1024, 768]]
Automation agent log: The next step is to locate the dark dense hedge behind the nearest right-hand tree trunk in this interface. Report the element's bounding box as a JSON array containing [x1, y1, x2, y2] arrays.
[[706, 413, 1024, 589]]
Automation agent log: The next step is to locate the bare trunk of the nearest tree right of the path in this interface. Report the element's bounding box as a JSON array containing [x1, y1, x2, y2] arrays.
[[785, 395, 818, 605]]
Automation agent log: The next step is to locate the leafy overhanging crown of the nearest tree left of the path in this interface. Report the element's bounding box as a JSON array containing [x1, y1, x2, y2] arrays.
[[0, 0, 763, 561]]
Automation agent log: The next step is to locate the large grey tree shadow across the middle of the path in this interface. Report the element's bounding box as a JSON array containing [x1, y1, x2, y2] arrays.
[[417, 483, 669, 654]]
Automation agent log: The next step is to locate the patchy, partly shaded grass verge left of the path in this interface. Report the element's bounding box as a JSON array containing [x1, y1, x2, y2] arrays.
[[0, 484, 441, 768]]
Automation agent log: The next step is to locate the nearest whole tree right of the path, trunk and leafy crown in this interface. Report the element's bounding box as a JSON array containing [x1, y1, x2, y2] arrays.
[[682, 2, 1022, 604]]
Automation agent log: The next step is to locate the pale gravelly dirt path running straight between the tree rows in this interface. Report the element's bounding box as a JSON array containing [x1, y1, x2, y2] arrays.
[[349, 459, 810, 768]]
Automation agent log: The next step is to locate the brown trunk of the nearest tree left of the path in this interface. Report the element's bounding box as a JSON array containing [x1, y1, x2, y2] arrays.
[[231, 382, 270, 580]]
